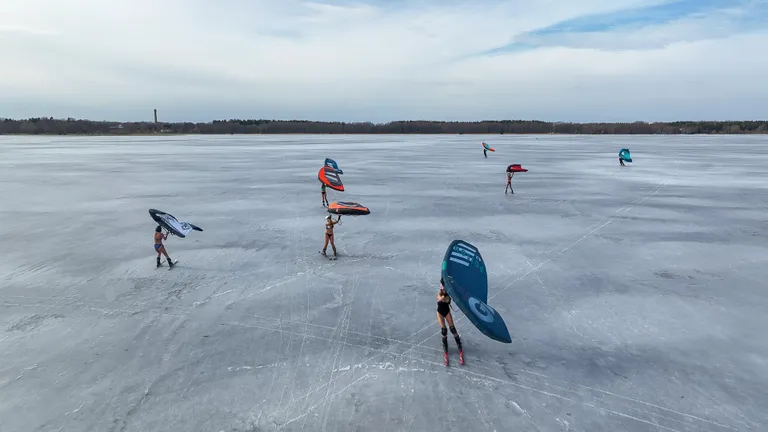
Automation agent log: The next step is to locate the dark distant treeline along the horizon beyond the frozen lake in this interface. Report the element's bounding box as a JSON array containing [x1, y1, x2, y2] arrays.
[[0, 117, 768, 135]]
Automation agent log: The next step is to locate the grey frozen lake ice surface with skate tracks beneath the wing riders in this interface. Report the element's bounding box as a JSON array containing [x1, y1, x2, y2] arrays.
[[0, 135, 768, 432]]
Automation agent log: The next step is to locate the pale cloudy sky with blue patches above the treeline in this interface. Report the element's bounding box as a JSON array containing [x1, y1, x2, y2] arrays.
[[0, 0, 768, 123]]
